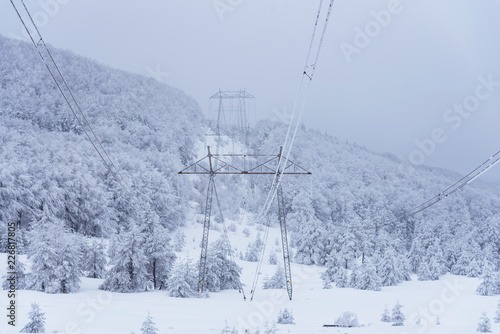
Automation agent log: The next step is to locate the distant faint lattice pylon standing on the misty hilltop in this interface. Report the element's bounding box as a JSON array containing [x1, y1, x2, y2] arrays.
[[209, 89, 255, 145]]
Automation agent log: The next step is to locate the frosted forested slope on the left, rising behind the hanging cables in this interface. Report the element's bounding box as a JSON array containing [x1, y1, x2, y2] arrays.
[[0, 36, 202, 236]]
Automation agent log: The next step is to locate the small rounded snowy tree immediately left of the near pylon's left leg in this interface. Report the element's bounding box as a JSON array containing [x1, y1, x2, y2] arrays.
[[168, 258, 198, 298]]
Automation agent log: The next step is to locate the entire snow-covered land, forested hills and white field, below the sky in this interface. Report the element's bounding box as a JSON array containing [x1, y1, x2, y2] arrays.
[[0, 36, 500, 334]]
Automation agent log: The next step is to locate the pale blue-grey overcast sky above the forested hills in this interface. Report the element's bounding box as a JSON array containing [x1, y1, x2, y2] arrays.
[[0, 0, 500, 182]]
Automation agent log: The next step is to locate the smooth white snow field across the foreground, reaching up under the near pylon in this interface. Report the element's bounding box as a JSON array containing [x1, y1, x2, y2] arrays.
[[0, 218, 500, 334]]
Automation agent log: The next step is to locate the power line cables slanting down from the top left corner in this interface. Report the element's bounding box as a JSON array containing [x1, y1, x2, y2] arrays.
[[10, 0, 131, 193]]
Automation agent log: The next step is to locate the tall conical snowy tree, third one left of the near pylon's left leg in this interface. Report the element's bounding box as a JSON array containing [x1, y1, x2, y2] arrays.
[[99, 225, 150, 292]]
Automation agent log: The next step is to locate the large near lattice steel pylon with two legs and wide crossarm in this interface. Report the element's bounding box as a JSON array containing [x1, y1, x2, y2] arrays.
[[179, 146, 311, 300]]
